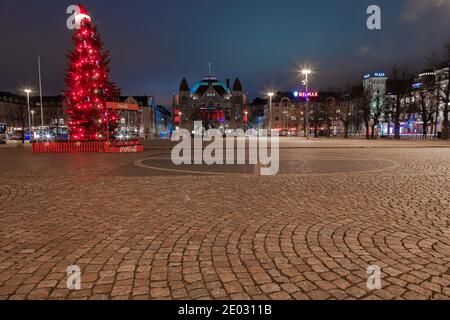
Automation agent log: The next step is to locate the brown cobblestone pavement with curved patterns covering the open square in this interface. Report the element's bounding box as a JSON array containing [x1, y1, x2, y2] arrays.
[[0, 140, 450, 300]]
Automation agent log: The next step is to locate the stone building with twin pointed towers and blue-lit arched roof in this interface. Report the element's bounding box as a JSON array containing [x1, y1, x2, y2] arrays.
[[172, 75, 249, 131]]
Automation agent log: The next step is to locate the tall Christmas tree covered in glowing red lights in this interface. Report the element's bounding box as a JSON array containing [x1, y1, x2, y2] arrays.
[[65, 5, 120, 141]]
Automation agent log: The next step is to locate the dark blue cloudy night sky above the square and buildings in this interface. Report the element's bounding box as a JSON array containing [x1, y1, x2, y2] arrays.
[[0, 0, 450, 104]]
